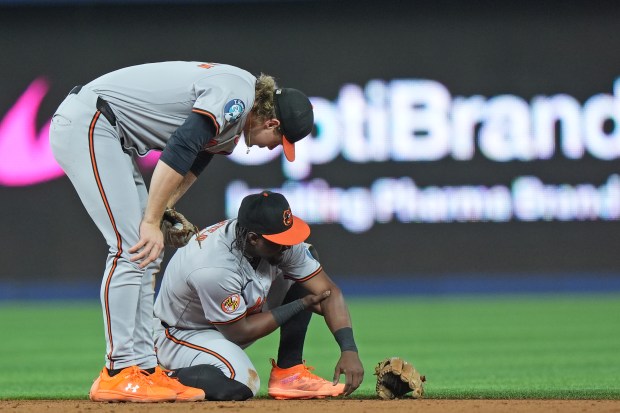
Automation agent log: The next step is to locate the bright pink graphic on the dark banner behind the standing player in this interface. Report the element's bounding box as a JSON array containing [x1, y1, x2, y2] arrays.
[[0, 78, 160, 186]]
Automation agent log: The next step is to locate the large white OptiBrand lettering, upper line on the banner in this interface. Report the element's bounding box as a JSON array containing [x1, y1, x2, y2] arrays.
[[229, 79, 620, 180]]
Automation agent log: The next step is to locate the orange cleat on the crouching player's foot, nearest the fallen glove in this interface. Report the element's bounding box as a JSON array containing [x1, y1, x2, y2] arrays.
[[268, 359, 344, 400]]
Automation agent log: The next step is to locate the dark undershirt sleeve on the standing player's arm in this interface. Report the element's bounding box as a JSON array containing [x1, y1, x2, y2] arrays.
[[159, 112, 215, 176]]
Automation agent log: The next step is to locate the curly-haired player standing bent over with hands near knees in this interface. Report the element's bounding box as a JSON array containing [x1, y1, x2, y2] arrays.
[[50, 62, 314, 402]]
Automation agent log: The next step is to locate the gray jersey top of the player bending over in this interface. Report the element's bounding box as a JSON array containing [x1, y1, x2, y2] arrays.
[[84, 62, 256, 155]]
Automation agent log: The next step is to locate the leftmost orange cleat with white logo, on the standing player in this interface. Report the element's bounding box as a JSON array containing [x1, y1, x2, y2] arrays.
[[89, 366, 177, 403]]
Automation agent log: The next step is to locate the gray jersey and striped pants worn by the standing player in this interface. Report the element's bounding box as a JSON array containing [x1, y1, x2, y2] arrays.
[[50, 62, 256, 369]]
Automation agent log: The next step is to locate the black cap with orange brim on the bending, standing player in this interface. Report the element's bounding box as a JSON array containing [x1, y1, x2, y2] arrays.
[[273, 88, 314, 162]]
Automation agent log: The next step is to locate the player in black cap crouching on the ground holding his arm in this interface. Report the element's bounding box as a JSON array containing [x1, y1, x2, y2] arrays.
[[155, 191, 364, 400]]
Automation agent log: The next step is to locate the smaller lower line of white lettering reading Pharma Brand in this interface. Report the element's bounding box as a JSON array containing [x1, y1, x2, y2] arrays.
[[226, 174, 620, 233]]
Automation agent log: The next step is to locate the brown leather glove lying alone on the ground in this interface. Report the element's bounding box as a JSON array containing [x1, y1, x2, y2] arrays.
[[375, 357, 426, 399]]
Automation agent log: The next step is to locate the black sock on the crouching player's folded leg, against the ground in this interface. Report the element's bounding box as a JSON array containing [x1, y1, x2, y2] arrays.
[[173, 364, 254, 401]]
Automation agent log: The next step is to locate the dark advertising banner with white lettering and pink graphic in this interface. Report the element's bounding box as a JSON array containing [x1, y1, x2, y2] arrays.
[[0, 1, 620, 279]]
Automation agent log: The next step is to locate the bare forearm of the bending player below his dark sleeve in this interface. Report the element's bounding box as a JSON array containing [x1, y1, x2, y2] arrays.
[[143, 161, 183, 225]]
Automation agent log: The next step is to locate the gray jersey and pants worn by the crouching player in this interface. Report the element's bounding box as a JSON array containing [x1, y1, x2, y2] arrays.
[[154, 220, 322, 395]]
